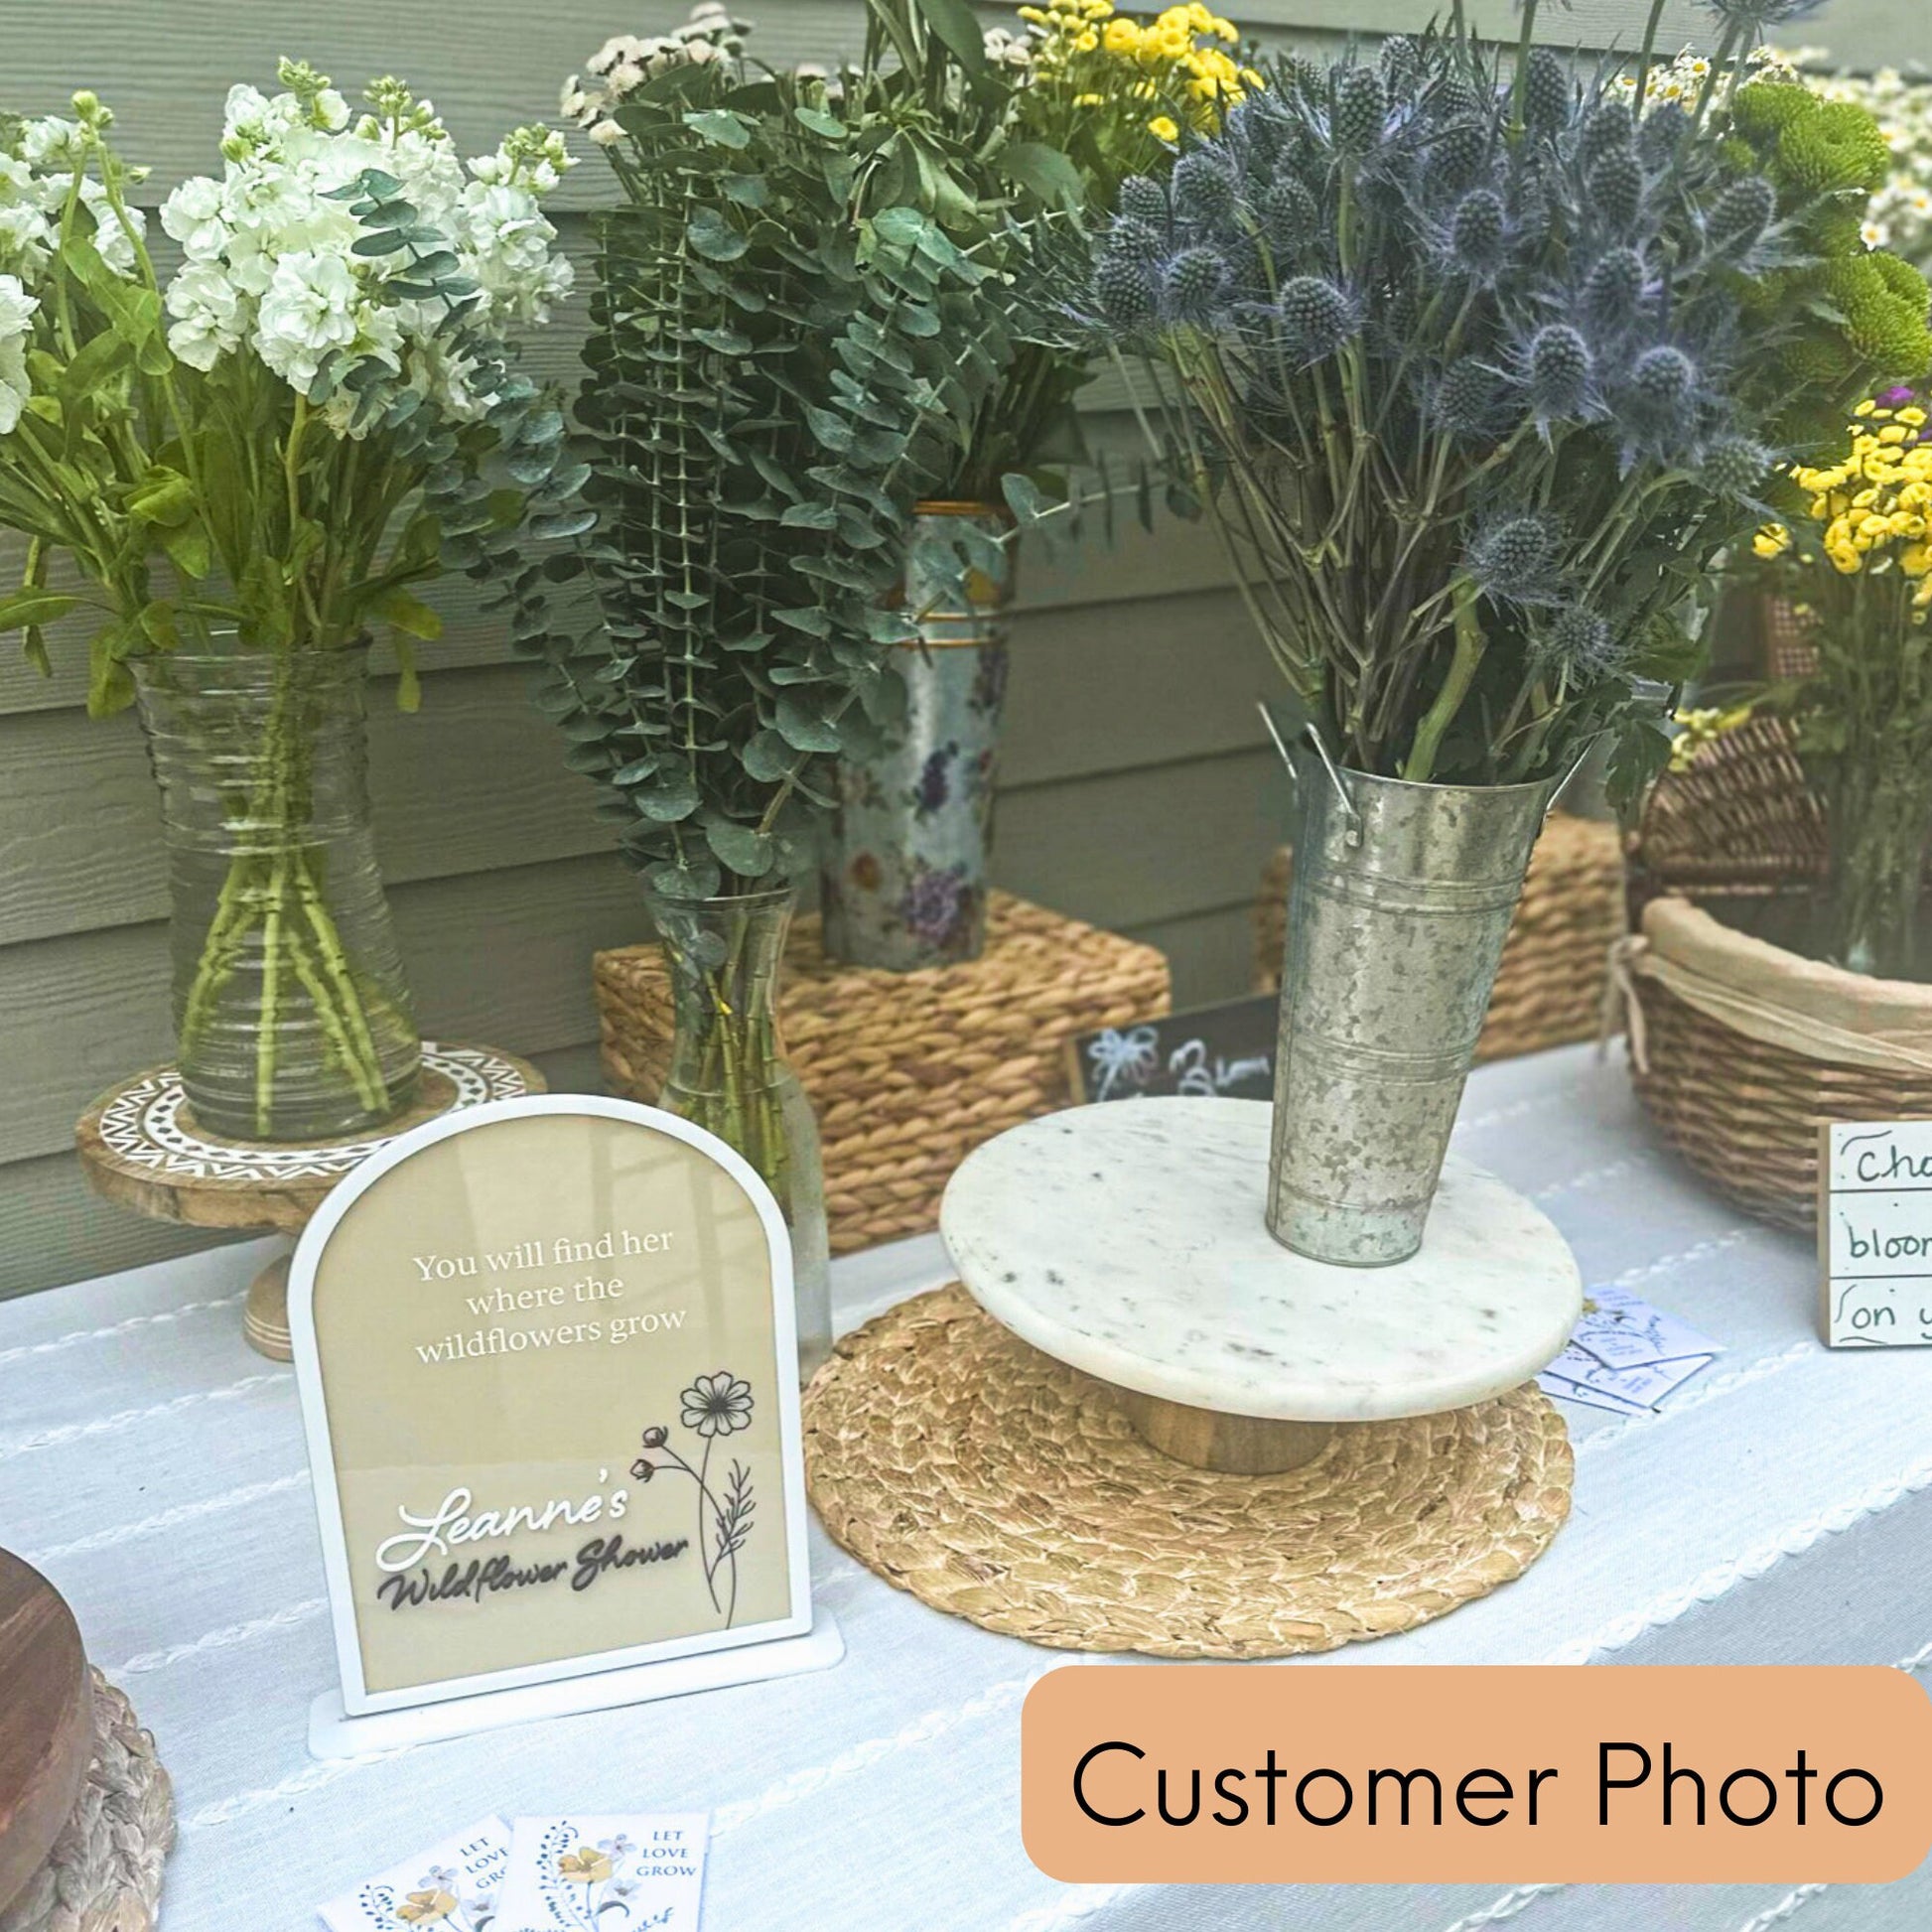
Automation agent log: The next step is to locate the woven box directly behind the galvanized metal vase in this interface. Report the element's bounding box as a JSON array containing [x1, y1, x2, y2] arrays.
[[1254, 811, 1623, 1060]]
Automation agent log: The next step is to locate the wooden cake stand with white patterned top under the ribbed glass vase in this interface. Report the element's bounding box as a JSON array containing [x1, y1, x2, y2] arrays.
[[73, 1039, 545, 1362]]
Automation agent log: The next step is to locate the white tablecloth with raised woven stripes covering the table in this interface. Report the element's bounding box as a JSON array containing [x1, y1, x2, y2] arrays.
[[0, 1049, 1932, 1932]]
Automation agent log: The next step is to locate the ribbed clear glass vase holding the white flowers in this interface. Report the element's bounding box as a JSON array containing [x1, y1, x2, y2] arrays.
[[133, 645, 421, 1142]]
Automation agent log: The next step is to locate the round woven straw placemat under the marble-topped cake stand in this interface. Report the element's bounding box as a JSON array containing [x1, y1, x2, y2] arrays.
[[805, 1287, 1571, 1658]]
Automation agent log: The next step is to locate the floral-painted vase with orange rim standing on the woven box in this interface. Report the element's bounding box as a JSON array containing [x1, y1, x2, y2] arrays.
[[819, 504, 1013, 972]]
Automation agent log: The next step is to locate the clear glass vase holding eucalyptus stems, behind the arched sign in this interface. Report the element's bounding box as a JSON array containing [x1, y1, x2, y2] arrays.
[[645, 887, 833, 1379]]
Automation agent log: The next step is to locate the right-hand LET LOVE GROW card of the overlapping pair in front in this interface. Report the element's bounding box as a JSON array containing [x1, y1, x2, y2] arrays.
[[490, 1812, 711, 1932]]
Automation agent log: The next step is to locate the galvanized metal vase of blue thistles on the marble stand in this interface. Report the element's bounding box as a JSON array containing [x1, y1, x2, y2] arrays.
[[1268, 746, 1559, 1268]]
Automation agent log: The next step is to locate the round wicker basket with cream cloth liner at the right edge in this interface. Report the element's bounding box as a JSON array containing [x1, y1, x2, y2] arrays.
[[1621, 717, 1932, 1229]]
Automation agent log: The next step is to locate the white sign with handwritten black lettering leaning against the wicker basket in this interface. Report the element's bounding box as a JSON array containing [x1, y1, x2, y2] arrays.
[[1818, 1121, 1932, 1348]]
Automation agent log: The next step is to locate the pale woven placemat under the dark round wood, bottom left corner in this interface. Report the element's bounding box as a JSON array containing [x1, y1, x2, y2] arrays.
[[0, 1671, 174, 1932]]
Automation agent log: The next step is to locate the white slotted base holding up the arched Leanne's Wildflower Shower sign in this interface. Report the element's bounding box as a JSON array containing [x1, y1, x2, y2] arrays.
[[309, 1609, 844, 1758]]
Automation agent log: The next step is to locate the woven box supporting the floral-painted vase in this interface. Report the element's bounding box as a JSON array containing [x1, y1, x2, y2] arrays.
[[595, 893, 1171, 1254]]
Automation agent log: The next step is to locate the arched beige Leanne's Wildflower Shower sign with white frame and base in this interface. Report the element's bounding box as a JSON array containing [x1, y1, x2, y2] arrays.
[[290, 1095, 839, 1754]]
